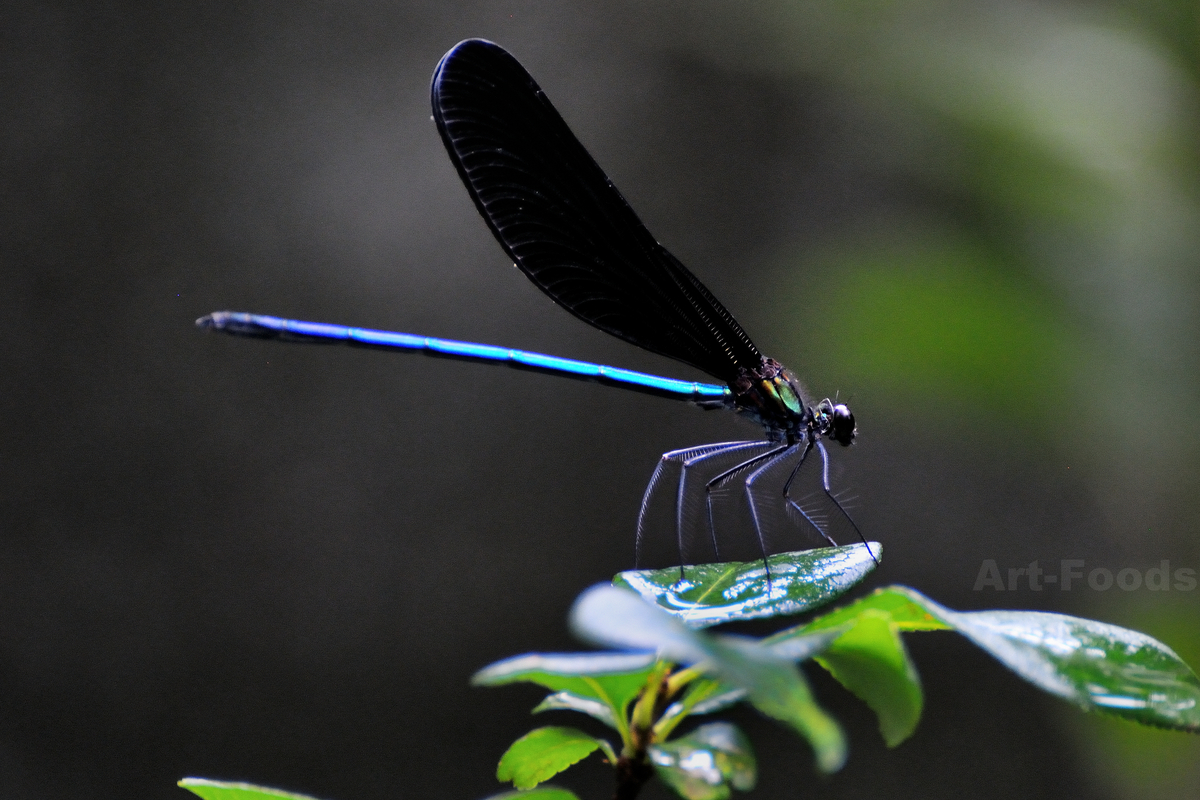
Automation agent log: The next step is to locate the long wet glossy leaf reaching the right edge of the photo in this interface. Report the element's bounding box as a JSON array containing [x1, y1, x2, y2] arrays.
[[896, 587, 1200, 732]]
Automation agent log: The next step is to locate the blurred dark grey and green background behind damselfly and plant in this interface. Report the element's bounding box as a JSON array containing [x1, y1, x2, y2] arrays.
[[0, 0, 1200, 800]]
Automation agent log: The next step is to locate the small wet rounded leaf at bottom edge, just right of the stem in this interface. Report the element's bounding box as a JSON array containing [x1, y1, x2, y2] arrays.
[[649, 722, 757, 800]]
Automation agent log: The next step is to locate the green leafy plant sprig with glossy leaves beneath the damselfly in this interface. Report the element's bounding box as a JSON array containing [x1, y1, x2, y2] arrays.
[[180, 542, 1200, 800]]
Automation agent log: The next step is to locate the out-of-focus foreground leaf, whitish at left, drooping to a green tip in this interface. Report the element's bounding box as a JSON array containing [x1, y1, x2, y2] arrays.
[[571, 585, 846, 772]]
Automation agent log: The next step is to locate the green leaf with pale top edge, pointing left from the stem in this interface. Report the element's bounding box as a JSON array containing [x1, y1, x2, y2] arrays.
[[470, 652, 654, 740]]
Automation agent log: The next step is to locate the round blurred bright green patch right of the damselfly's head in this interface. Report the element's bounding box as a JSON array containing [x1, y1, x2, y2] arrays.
[[805, 240, 1078, 433]]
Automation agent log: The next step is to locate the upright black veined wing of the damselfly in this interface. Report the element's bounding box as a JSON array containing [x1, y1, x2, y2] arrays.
[[432, 38, 762, 383]]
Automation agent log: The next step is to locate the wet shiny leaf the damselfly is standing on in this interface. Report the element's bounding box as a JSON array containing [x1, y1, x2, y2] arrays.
[[613, 542, 883, 627]]
